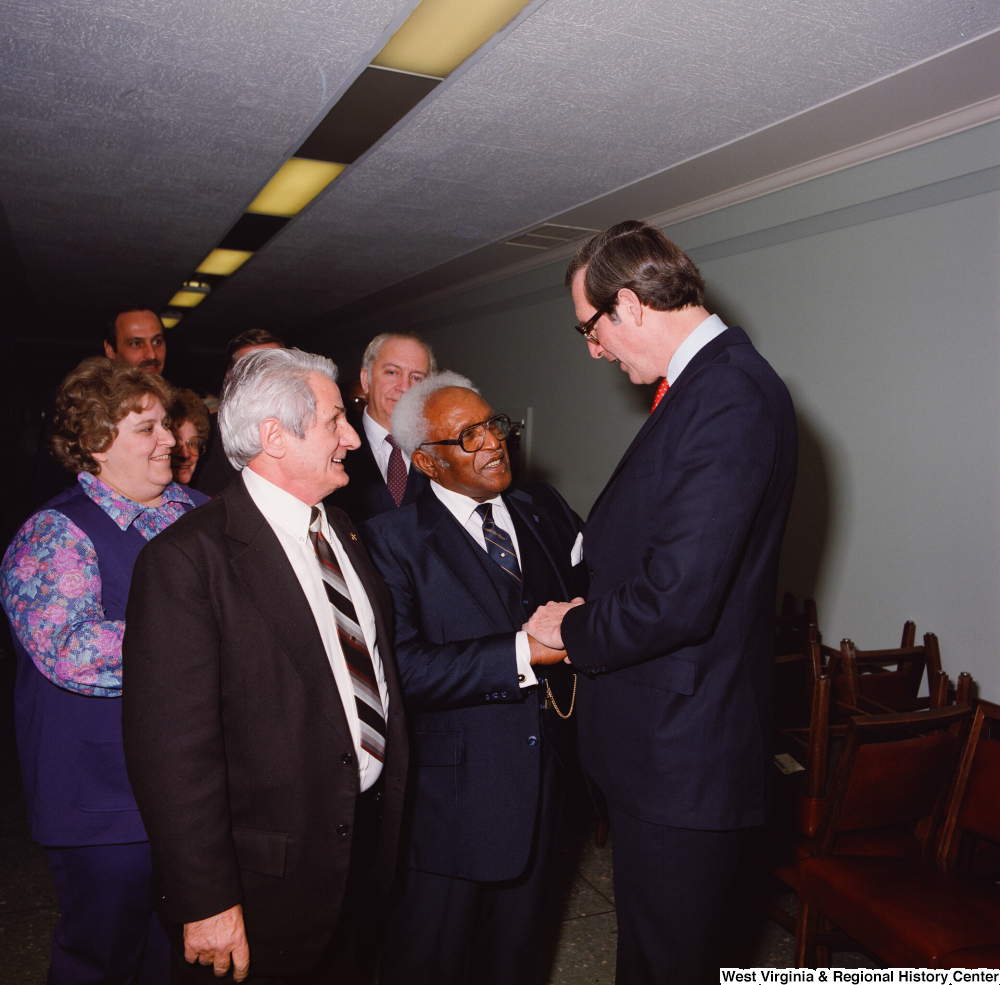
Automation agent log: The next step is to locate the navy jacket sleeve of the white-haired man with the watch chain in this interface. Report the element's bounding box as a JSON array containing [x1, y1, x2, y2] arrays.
[[365, 523, 524, 711]]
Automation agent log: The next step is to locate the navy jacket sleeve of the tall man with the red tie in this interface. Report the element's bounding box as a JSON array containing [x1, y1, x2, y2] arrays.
[[562, 365, 777, 673]]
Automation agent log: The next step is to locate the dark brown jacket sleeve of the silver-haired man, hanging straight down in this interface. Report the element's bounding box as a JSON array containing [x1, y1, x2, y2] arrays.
[[122, 538, 242, 923]]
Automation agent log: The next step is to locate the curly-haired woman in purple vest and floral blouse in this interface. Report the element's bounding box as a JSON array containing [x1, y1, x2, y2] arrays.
[[0, 358, 206, 985]]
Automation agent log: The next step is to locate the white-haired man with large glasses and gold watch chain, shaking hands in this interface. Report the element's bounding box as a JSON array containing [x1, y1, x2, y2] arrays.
[[365, 373, 584, 985]]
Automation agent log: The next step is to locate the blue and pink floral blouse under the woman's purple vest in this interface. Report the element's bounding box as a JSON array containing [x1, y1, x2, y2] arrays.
[[0, 472, 201, 698]]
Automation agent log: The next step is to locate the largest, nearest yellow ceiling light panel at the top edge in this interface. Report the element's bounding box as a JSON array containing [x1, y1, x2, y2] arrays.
[[372, 0, 529, 79]]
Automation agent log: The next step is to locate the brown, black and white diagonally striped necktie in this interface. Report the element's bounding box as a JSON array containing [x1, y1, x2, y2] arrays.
[[309, 506, 385, 762]]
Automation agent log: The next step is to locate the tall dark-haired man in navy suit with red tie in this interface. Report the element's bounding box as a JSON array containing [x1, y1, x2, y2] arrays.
[[528, 222, 796, 985]]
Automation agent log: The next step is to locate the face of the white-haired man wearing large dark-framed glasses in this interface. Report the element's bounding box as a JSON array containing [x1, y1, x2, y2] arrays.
[[412, 387, 511, 503]]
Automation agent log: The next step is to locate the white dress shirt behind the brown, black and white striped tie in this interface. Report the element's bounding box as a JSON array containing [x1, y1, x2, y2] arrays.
[[242, 468, 389, 791]]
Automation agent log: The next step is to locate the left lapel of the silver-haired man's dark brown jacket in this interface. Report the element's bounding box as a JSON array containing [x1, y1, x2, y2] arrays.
[[222, 479, 352, 742]]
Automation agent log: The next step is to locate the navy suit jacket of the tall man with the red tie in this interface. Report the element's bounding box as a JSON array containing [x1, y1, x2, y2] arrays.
[[562, 328, 797, 830]]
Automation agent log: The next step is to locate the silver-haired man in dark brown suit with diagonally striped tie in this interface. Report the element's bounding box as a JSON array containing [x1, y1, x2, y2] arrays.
[[123, 349, 407, 985]]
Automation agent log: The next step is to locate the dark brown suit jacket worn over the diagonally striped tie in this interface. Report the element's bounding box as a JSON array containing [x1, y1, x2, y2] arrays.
[[122, 481, 407, 976]]
